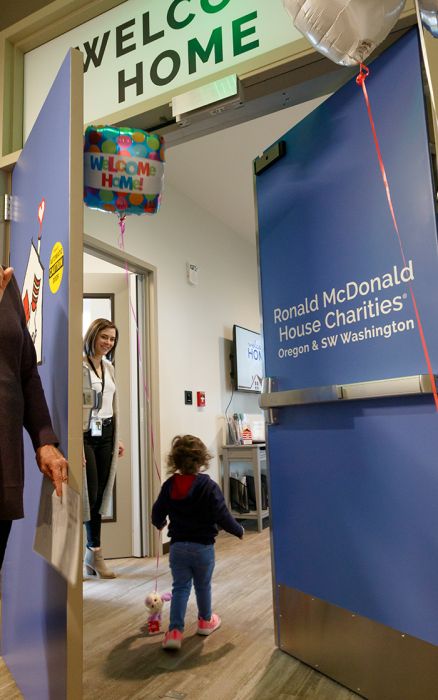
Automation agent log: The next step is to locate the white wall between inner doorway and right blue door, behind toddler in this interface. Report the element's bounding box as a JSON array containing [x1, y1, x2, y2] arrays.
[[85, 180, 260, 480]]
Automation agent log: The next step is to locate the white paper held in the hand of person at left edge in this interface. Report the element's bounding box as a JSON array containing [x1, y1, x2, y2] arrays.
[[33, 478, 82, 584]]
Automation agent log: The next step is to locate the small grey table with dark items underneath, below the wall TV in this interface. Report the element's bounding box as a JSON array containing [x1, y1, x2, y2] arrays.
[[222, 443, 269, 532]]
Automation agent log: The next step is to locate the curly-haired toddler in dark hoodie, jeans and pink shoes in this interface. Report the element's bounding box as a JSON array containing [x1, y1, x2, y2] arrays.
[[152, 435, 244, 649]]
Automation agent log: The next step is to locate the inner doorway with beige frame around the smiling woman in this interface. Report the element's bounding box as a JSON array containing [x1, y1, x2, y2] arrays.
[[83, 241, 158, 559]]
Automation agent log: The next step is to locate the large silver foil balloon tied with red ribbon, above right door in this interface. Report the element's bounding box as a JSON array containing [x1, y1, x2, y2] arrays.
[[283, 0, 408, 66]]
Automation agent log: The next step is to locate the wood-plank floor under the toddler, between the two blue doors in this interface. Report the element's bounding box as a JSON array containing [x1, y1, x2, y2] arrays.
[[82, 523, 359, 700]]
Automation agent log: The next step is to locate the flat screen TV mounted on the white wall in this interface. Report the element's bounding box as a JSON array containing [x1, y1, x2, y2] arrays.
[[233, 326, 264, 393]]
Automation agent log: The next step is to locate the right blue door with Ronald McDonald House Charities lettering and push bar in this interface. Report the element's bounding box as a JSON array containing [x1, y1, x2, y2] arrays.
[[255, 32, 438, 700]]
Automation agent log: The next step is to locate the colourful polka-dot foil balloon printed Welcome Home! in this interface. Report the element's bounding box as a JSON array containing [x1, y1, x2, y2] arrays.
[[84, 126, 164, 217]]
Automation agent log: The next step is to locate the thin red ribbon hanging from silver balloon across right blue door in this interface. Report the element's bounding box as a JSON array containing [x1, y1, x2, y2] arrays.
[[356, 63, 438, 411]]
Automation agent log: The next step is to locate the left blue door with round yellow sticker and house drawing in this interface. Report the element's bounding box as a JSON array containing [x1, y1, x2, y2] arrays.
[[2, 51, 83, 700]]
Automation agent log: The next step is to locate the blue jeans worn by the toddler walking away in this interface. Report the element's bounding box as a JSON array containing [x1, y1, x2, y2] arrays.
[[169, 542, 214, 632]]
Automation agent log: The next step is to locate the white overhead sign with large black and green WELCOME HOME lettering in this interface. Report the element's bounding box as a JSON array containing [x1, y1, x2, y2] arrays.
[[24, 0, 301, 138]]
